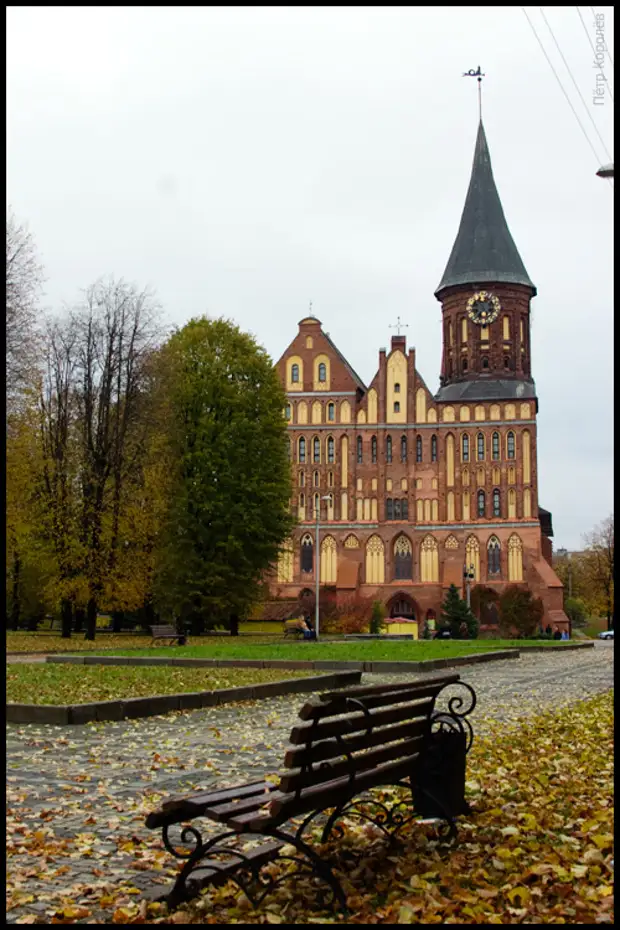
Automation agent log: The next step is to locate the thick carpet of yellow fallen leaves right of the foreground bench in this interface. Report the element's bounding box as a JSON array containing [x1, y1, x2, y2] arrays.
[[140, 694, 613, 924]]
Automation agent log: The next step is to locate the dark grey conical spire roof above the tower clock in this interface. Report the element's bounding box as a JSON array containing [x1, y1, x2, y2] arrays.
[[435, 121, 536, 296]]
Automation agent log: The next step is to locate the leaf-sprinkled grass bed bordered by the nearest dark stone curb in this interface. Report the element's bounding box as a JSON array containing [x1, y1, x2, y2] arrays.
[[6, 664, 314, 704]]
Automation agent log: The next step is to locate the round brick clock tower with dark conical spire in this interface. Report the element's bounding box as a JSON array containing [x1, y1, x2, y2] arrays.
[[435, 122, 536, 401]]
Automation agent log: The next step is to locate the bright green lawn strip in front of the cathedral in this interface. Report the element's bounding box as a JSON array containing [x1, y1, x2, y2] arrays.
[[101, 637, 572, 662]]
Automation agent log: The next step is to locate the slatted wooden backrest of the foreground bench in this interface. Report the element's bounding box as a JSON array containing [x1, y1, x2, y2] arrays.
[[270, 674, 460, 815]]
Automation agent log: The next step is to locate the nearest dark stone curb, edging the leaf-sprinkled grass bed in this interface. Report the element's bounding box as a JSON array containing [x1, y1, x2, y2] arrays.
[[6, 657, 362, 726]]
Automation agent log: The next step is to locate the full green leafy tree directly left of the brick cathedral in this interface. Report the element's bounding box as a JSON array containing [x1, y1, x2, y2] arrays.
[[155, 317, 293, 631]]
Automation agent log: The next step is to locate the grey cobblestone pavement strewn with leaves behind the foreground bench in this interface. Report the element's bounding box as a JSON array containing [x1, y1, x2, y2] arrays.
[[7, 642, 614, 923]]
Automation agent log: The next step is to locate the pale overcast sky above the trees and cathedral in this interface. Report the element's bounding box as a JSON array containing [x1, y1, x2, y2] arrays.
[[7, 7, 613, 548]]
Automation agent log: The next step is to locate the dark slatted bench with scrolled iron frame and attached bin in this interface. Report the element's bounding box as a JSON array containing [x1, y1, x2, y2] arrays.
[[146, 674, 476, 910]]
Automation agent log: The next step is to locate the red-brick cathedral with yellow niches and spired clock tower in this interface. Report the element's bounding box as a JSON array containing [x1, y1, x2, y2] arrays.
[[270, 123, 568, 629]]
